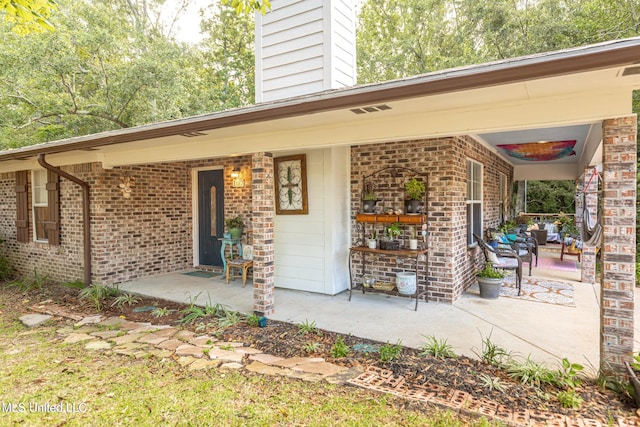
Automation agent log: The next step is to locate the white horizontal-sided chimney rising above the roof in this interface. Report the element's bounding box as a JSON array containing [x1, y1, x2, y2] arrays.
[[256, 0, 356, 103]]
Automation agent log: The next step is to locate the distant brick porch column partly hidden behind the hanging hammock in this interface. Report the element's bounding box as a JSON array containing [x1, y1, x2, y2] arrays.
[[576, 168, 599, 285]]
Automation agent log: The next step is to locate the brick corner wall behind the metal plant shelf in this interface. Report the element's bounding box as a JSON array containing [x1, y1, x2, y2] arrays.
[[351, 137, 513, 303]]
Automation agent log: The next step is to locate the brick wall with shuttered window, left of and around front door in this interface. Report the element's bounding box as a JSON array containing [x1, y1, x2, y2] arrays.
[[0, 157, 251, 284]]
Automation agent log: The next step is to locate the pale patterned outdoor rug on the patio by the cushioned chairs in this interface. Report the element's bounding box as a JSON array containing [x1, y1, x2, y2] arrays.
[[469, 274, 576, 307]]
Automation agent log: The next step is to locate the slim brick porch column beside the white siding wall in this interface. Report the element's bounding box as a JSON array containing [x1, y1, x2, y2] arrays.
[[251, 153, 275, 316]]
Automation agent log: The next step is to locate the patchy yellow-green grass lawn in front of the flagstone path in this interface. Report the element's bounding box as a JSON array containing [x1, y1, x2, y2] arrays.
[[0, 308, 498, 427]]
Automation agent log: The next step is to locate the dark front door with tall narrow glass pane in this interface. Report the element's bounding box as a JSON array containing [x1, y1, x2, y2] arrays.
[[198, 170, 224, 267]]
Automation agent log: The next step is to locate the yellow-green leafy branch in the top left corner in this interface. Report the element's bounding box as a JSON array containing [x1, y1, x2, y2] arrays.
[[0, 0, 57, 34]]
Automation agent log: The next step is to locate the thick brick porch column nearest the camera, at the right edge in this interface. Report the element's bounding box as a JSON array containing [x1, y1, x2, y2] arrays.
[[600, 115, 637, 375]]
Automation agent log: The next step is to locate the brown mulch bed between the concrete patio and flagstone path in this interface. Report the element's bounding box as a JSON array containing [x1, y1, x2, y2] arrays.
[[0, 285, 635, 425]]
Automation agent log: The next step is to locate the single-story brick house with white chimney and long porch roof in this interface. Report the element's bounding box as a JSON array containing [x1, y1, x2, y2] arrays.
[[0, 1, 640, 372]]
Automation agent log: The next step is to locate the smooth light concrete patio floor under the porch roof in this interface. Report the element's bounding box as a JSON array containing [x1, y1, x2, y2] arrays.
[[120, 251, 640, 378]]
